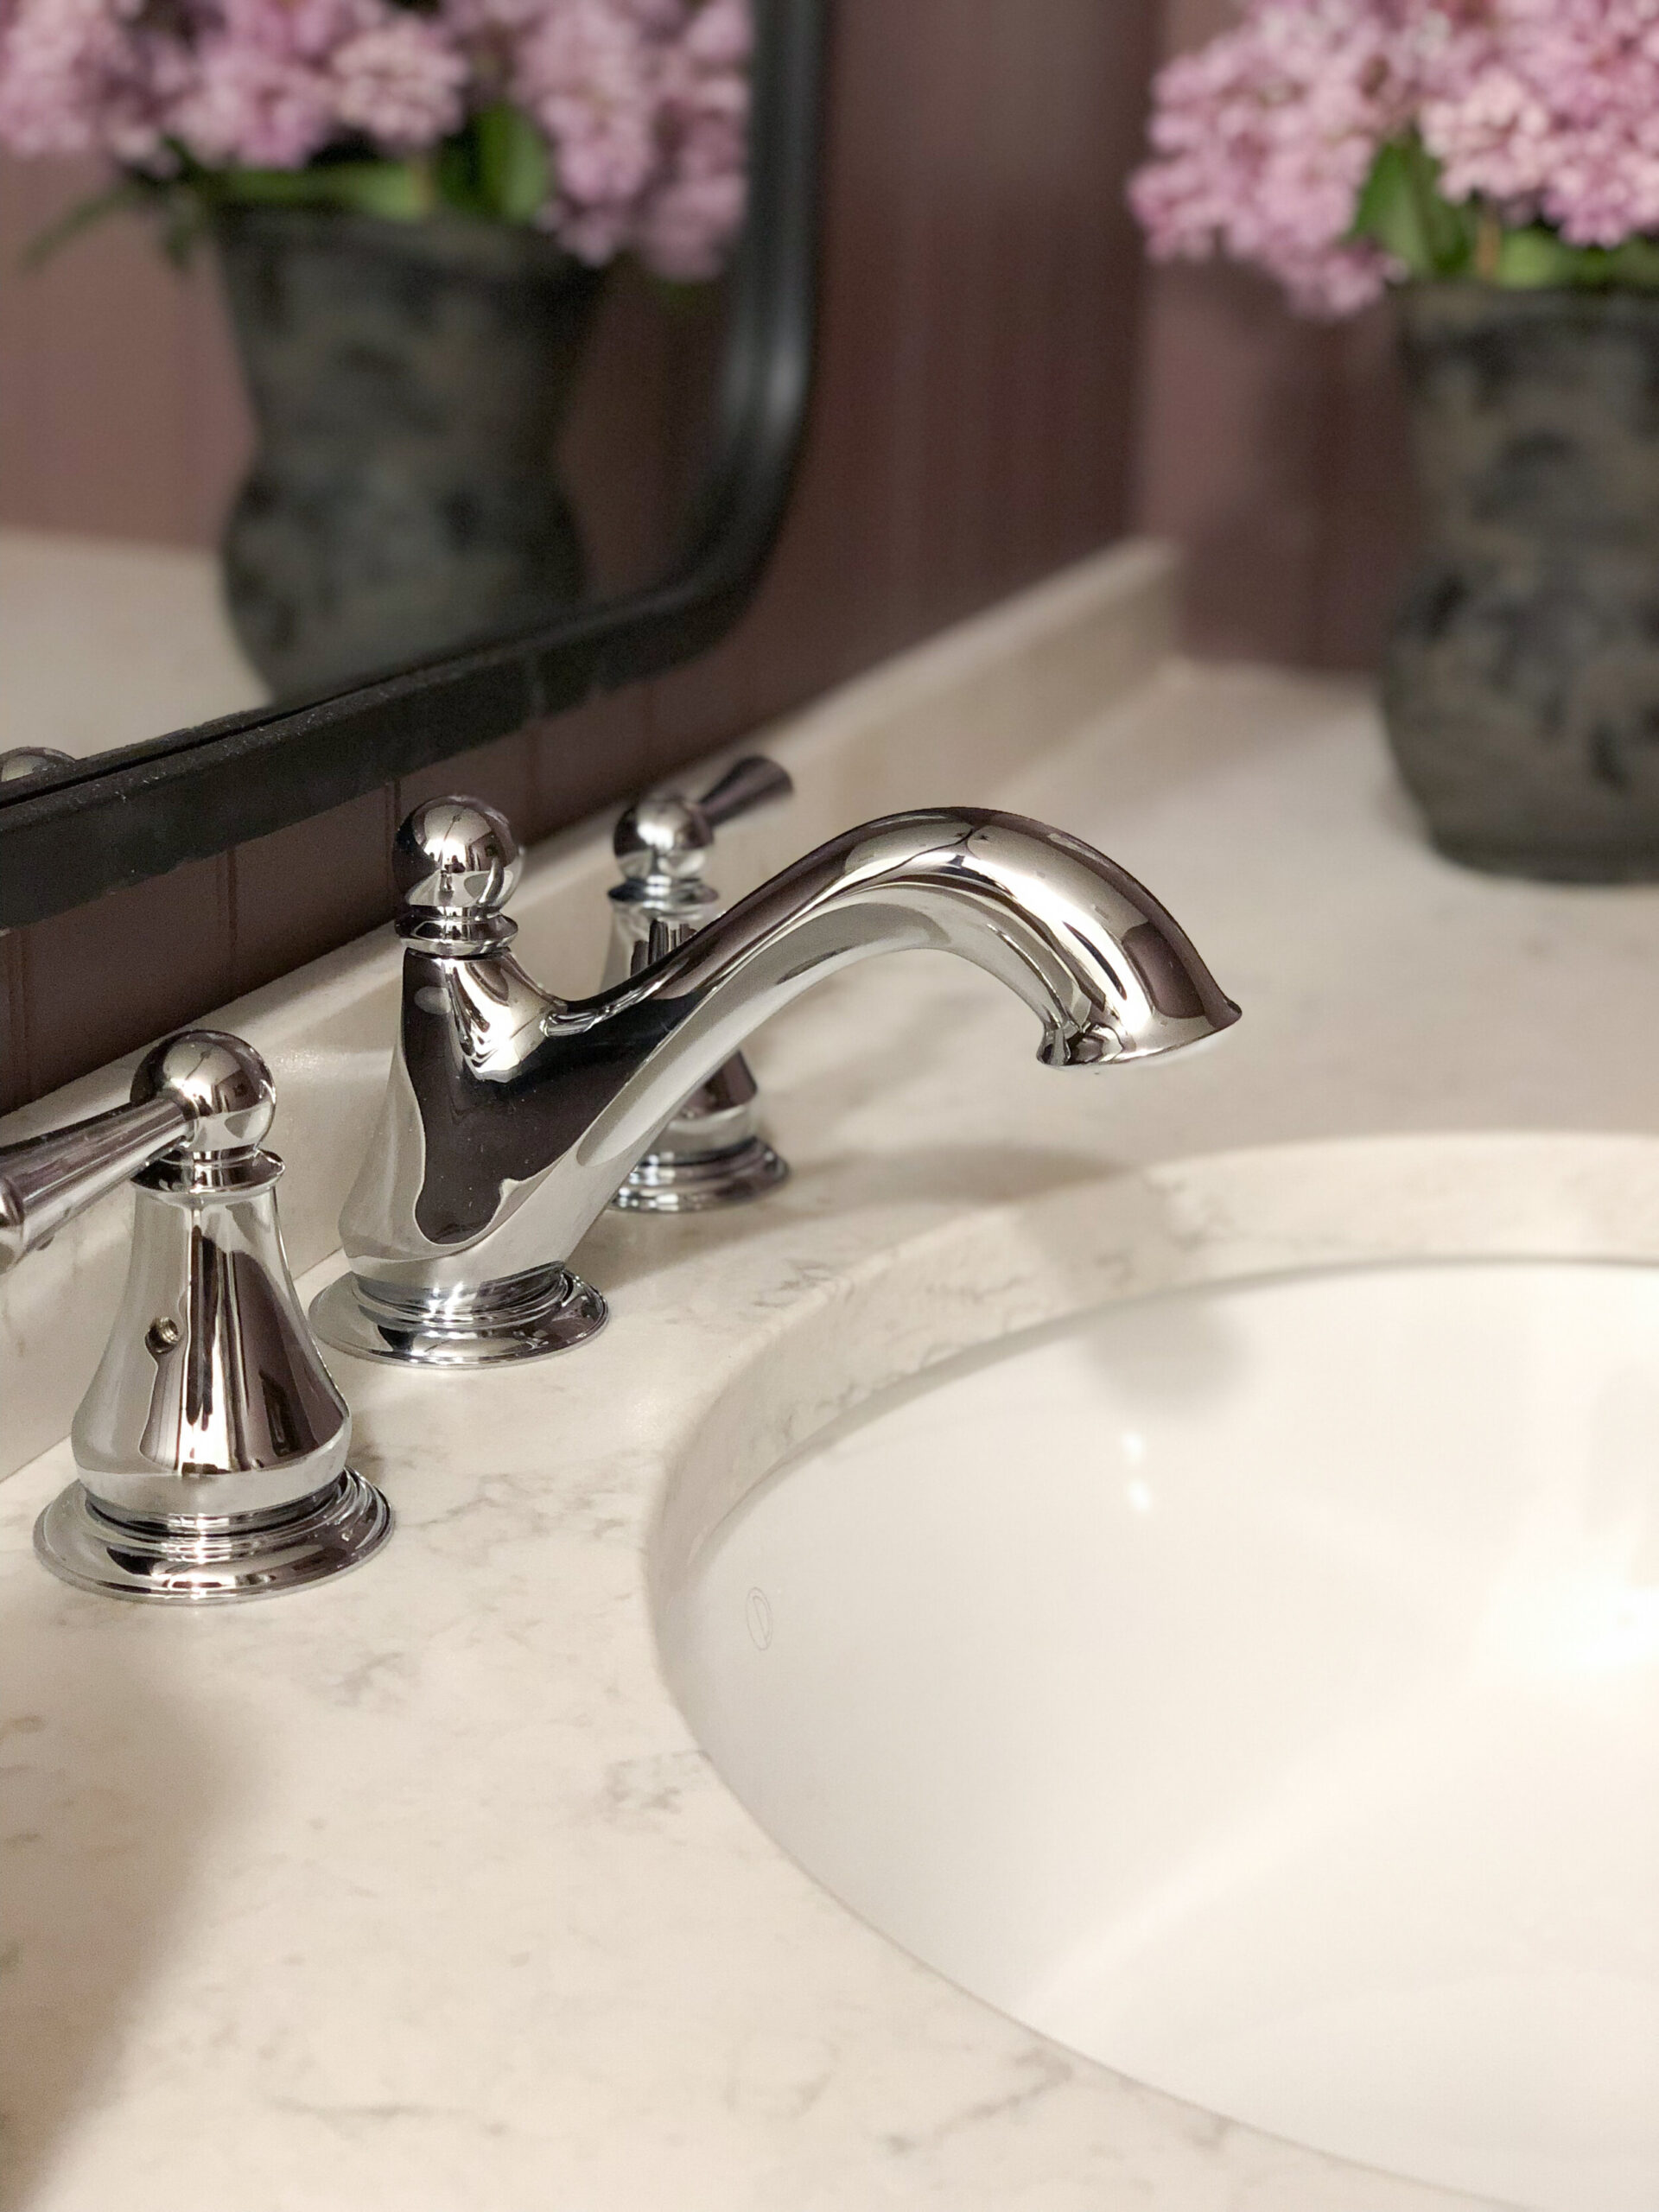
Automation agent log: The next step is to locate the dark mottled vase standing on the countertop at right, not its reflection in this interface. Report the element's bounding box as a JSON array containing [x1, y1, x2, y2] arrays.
[[1382, 285, 1659, 882]]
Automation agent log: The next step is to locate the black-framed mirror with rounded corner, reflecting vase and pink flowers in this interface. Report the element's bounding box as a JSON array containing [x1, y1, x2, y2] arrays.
[[0, 0, 821, 927]]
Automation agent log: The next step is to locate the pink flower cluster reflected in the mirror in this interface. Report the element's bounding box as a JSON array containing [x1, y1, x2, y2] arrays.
[[0, 0, 750, 276]]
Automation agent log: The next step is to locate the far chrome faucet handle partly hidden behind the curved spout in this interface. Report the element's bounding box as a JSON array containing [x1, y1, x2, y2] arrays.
[[604, 754, 794, 1214]]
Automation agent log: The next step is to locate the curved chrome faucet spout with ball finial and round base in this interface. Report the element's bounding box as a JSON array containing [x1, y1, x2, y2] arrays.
[[312, 798, 1239, 1367]]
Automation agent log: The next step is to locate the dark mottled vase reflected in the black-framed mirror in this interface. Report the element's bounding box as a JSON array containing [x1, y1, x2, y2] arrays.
[[214, 206, 604, 699]]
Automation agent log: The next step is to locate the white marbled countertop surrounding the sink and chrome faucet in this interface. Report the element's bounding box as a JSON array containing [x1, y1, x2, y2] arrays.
[[0, 614, 1659, 2212]]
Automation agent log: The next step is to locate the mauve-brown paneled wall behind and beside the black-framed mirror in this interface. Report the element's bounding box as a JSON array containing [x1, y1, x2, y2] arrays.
[[0, 0, 1157, 1106]]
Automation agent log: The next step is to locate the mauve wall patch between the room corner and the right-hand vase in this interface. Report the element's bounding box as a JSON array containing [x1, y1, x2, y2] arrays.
[[1133, 0, 1411, 668]]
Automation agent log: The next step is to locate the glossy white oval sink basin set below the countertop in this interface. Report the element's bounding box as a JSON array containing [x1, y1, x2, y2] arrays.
[[659, 1261, 1659, 2212]]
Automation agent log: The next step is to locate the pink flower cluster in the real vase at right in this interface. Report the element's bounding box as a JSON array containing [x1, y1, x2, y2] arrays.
[[1130, 0, 1659, 315]]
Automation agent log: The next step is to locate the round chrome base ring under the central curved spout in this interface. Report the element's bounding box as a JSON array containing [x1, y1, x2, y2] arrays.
[[309, 1268, 608, 1367]]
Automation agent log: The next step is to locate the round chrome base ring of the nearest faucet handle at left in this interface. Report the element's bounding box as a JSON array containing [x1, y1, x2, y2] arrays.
[[35, 1466, 391, 1606]]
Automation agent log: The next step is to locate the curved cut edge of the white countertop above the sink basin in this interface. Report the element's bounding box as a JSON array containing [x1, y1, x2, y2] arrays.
[[644, 1128, 1659, 1618]]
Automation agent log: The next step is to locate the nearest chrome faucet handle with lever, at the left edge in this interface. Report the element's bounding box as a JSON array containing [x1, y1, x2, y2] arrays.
[[0, 1028, 391, 1604]]
